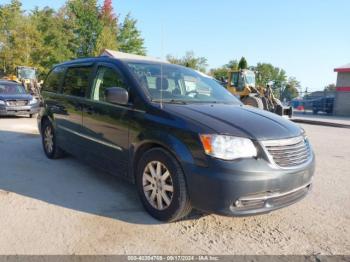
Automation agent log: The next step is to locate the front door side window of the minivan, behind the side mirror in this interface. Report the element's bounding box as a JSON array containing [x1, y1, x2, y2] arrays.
[[92, 67, 126, 101]]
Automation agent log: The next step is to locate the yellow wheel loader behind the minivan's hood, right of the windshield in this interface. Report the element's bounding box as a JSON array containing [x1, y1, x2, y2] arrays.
[[226, 69, 293, 118]]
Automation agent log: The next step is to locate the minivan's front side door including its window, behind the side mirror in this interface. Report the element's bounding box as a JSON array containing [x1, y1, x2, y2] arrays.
[[83, 63, 130, 176]]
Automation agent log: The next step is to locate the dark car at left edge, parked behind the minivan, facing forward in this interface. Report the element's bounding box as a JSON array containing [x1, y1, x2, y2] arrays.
[[0, 80, 40, 117]]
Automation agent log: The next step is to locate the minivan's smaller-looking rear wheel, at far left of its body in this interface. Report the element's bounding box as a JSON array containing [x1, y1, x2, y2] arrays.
[[41, 121, 63, 159]]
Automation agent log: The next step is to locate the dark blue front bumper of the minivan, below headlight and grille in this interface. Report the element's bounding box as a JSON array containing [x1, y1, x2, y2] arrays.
[[184, 154, 315, 216]]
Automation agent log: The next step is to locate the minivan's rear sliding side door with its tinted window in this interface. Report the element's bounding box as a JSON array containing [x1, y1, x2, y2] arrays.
[[55, 64, 93, 156]]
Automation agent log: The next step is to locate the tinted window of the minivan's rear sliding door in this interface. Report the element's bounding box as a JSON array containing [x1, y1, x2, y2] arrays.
[[63, 66, 92, 97]]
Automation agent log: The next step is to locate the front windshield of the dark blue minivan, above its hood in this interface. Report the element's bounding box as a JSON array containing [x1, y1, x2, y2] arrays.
[[128, 62, 240, 104]]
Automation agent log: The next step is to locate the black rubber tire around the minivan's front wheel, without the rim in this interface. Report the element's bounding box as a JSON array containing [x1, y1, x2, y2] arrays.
[[136, 148, 192, 222]]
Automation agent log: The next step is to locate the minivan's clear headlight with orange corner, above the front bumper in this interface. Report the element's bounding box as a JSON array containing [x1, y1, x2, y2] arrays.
[[200, 135, 257, 160]]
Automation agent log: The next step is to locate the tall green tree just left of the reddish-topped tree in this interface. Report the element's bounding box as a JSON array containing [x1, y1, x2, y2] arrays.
[[67, 0, 103, 57]]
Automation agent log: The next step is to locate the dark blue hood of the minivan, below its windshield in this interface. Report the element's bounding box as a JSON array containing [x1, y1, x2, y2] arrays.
[[164, 104, 302, 140]]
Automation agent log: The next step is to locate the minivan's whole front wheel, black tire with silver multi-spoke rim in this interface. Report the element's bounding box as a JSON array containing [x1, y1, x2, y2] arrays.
[[136, 148, 192, 222]]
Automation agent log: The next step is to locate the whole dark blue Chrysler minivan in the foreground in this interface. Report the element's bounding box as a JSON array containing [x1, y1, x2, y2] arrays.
[[38, 57, 315, 221]]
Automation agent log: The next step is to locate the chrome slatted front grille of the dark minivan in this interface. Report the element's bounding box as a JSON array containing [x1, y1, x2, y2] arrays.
[[262, 136, 311, 167]]
